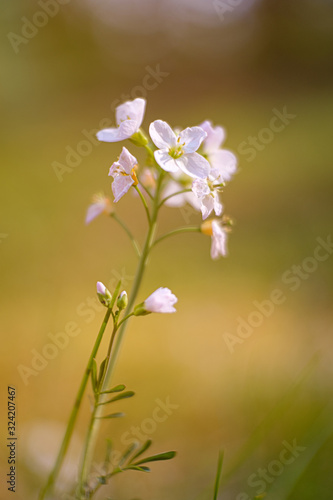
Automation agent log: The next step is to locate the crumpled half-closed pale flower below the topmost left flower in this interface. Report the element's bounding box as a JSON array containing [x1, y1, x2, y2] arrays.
[[109, 148, 138, 203]]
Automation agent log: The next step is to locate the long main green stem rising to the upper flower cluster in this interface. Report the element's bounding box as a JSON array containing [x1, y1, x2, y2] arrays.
[[78, 169, 164, 496]]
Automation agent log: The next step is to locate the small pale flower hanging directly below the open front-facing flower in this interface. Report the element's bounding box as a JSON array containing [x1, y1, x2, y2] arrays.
[[192, 171, 223, 220]]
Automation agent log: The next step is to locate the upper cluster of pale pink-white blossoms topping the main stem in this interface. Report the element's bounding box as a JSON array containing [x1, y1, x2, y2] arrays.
[[86, 98, 237, 259]]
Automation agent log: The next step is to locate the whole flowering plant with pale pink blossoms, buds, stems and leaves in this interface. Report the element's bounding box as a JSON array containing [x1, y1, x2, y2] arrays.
[[39, 98, 237, 500]]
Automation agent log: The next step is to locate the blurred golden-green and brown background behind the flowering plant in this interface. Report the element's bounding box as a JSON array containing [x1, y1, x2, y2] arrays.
[[0, 0, 333, 500]]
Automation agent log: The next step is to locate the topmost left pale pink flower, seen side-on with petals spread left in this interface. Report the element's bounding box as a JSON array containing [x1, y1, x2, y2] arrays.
[[97, 97, 146, 142]]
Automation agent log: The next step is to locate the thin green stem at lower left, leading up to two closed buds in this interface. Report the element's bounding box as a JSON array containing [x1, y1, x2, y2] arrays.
[[38, 309, 111, 500]]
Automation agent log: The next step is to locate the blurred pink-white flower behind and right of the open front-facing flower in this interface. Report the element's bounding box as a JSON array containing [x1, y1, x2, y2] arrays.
[[199, 120, 237, 182]]
